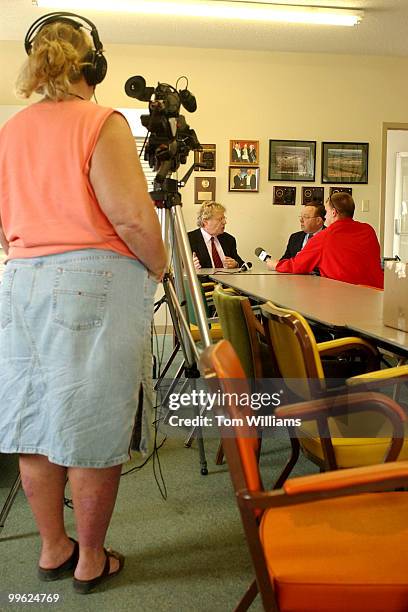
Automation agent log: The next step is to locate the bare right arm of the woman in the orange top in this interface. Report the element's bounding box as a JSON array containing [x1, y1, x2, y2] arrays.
[[89, 113, 166, 279]]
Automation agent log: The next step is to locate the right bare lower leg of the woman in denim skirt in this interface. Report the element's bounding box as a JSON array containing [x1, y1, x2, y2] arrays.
[[68, 465, 122, 580]]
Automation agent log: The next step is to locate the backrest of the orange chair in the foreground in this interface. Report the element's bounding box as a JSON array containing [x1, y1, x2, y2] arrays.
[[200, 340, 263, 491]]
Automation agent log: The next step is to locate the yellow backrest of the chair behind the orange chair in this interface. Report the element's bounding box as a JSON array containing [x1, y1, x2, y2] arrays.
[[261, 302, 325, 399]]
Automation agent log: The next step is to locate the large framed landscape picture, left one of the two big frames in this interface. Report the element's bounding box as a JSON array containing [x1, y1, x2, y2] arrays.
[[269, 140, 316, 182]]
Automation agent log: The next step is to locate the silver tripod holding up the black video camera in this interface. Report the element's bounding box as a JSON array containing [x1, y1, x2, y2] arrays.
[[150, 175, 211, 476]]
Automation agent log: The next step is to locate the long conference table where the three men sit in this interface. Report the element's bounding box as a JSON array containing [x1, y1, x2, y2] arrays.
[[207, 268, 408, 357]]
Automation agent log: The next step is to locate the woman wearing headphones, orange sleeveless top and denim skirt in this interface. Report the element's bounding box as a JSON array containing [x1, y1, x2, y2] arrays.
[[0, 13, 166, 593]]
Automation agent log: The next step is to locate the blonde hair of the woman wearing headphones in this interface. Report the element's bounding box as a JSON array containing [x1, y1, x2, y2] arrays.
[[16, 22, 92, 100]]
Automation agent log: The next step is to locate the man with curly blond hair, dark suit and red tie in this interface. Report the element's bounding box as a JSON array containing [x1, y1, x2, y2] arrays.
[[188, 201, 244, 270]]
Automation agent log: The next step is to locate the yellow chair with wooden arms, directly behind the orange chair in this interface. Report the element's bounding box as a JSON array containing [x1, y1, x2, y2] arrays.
[[261, 302, 408, 484]]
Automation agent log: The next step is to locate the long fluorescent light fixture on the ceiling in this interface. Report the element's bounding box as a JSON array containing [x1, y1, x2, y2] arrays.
[[32, 0, 363, 26]]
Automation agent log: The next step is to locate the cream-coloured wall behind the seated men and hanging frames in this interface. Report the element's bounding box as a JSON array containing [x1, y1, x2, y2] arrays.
[[0, 42, 408, 260]]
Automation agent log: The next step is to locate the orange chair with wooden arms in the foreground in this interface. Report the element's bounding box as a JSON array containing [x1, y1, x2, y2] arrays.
[[200, 340, 408, 612]]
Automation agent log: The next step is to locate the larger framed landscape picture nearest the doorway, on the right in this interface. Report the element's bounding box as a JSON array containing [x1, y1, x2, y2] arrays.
[[322, 142, 368, 183]]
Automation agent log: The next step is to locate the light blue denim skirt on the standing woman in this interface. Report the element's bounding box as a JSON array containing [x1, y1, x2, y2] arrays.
[[0, 249, 157, 468]]
